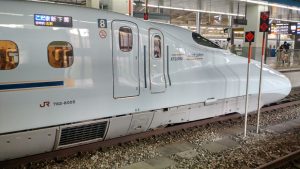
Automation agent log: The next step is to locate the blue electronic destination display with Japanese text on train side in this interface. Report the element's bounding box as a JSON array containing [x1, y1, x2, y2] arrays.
[[34, 14, 73, 27]]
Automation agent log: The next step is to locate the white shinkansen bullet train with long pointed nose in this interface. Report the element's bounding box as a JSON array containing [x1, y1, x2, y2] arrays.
[[0, 0, 291, 161]]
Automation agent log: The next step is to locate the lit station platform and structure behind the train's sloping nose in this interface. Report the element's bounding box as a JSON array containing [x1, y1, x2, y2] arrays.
[[39, 0, 300, 68]]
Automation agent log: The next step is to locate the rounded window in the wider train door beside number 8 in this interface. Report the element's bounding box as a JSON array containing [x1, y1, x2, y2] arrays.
[[119, 26, 132, 52]]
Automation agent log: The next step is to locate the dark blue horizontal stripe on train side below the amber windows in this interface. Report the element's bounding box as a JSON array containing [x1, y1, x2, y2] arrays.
[[0, 81, 64, 91]]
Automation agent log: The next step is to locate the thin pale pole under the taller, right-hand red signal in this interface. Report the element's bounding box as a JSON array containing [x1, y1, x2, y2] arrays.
[[256, 32, 266, 134]]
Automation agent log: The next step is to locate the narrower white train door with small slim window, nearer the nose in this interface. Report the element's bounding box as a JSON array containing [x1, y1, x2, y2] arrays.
[[149, 29, 167, 93]]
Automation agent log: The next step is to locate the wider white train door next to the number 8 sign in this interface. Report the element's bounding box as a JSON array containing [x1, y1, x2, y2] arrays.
[[112, 21, 140, 98]]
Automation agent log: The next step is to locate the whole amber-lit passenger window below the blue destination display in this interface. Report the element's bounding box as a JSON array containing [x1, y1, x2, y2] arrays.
[[48, 41, 74, 68]]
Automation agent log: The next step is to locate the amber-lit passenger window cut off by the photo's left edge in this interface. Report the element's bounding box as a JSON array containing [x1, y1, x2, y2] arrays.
[[0, 40, 19, 70]]
